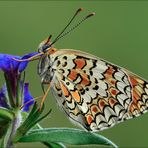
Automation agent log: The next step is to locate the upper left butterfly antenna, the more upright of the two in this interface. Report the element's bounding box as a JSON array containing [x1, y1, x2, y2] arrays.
[[52, 8, 83, 44]]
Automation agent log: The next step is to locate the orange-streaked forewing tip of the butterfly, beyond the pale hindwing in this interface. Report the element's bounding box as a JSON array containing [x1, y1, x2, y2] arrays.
[[124, 71, 148, 117]]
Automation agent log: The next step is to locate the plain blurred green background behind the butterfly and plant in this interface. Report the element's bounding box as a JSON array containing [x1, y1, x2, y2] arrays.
[[0, 0, 148, 147]]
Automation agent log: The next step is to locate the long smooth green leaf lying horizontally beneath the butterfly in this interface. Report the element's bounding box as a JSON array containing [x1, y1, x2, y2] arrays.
[[19, 128, 117, 147]]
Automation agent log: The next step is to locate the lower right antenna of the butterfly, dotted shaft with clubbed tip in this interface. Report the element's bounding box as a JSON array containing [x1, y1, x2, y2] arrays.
[[51, 12, 95, 45]]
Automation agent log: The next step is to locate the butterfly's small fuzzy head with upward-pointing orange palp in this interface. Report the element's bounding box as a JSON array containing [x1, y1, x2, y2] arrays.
[[38, 35, 52, 53]]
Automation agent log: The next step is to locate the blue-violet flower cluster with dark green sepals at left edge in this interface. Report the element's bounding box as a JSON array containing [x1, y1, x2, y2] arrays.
[[0, 52, 37, 111]]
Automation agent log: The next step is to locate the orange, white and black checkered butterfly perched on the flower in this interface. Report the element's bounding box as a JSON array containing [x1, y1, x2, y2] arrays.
[[24, 9, 148, 131]]
